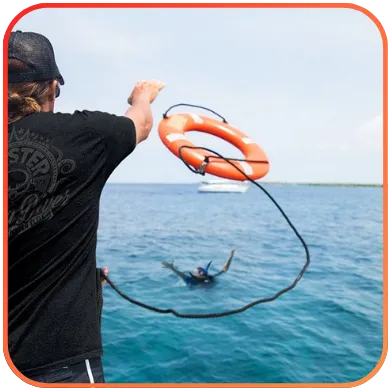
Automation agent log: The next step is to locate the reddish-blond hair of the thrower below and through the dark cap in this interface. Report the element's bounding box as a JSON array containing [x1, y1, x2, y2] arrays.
[[8, 59, 54, 124]]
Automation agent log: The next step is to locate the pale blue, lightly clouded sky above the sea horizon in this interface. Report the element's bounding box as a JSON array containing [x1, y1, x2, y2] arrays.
[[10, 9, 383, 183]]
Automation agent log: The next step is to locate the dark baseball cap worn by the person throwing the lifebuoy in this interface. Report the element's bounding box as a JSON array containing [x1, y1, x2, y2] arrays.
[[8, 31, 65, 85]]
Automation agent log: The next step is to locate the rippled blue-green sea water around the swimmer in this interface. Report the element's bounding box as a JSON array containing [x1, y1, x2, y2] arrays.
[[97, 184, 383, 383]]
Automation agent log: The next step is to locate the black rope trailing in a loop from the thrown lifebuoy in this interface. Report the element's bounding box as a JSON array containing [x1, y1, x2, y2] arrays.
[[101, 104, 310, 319]]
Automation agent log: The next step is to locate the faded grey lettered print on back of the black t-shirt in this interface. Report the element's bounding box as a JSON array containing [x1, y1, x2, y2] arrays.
[[8, 128, 76, 236]]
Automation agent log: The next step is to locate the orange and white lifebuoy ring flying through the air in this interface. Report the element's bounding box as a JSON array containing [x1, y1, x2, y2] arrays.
[[158, 113, 269, 181]]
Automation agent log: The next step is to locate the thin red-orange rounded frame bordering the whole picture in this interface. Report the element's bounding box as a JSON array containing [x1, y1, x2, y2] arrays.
[[2, 2, 388, 388]]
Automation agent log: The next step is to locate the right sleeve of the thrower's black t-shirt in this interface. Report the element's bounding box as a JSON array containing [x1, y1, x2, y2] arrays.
[[81, 111, 136, 176]]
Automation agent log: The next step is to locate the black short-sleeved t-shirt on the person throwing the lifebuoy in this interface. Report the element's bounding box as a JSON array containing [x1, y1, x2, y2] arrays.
[[8, 111, 136, 372]]
